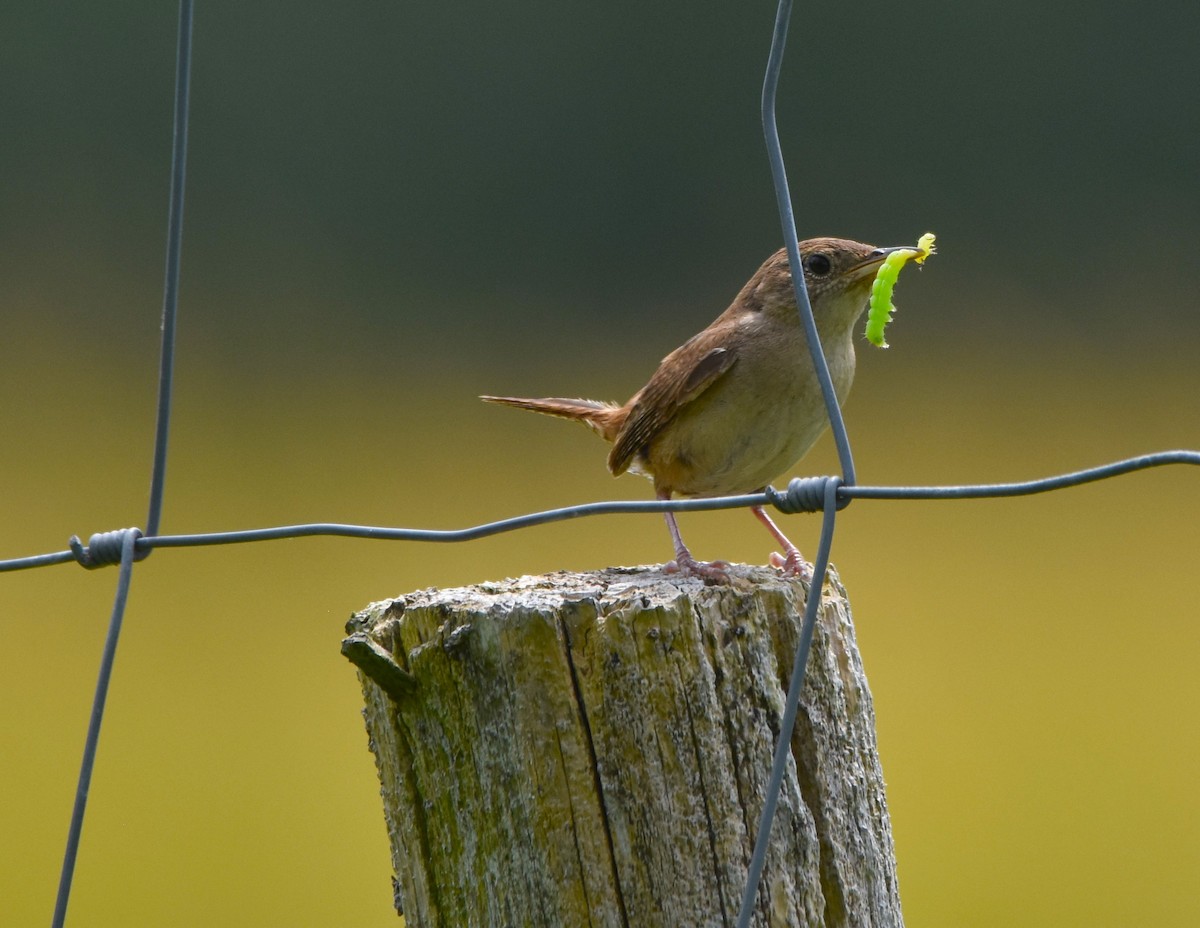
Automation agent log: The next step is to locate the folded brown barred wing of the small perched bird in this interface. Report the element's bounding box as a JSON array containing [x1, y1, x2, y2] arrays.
[[608, 329, 737, 474]]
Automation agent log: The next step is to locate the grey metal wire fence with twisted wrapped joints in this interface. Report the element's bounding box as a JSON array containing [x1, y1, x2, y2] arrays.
[[0, 0, 1200, 928]]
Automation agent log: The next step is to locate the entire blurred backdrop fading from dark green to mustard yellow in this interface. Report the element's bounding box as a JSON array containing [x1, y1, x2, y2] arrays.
[[0, 0, 1200, 928]]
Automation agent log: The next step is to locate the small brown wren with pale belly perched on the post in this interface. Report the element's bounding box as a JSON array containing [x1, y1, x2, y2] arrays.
[[480, 238, 916, 582]]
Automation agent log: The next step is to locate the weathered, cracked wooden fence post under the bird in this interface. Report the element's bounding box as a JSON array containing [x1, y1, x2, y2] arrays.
[[342, 567, 902, 928]]
